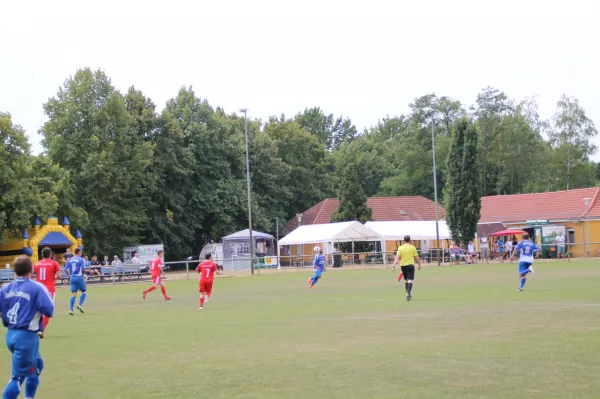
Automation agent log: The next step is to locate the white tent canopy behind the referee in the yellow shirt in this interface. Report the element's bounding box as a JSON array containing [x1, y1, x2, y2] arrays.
[[365, 220, 452, 241]]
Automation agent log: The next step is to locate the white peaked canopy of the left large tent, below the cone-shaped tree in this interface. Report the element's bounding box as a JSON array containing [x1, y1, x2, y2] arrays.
[[279, 222, 381, 245]]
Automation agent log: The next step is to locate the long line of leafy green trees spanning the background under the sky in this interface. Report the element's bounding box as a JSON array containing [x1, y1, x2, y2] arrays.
[[0, 68, 600, 258]]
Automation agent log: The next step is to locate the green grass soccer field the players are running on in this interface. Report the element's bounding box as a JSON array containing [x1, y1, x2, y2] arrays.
[[0, 261, 600, 399]]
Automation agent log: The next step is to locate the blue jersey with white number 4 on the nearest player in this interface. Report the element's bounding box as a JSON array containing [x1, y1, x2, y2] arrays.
[[0, 278, 54, 332]]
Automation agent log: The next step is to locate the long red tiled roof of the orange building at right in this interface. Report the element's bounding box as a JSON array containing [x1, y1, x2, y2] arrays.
[[479, 187, 600, 223]]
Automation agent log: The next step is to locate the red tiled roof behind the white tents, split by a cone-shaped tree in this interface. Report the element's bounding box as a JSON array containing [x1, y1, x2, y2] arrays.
[[284, 196, 445, 233]]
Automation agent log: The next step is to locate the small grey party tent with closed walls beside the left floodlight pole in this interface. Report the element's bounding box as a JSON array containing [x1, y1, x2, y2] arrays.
[[221, 229, 275, 270]]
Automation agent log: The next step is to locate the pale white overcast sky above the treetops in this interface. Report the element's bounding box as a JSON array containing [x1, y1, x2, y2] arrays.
[[0, 0, 600, 160]]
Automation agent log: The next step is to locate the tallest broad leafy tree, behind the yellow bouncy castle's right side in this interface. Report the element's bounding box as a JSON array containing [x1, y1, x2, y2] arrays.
[[42, 69, 153, 253]]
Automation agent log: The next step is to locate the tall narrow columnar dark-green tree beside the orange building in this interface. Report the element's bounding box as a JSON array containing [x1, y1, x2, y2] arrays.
[[444, 117, 481, 243]]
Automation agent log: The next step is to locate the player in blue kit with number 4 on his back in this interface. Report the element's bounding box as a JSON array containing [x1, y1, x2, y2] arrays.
[[0, 256, 54, 399]]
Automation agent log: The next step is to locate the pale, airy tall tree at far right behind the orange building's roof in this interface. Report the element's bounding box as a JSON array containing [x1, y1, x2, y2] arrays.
[[549, 94, 598, 190]]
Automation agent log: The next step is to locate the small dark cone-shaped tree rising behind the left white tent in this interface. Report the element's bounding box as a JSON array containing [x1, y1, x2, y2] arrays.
[[331, 166, 371, 223]]
